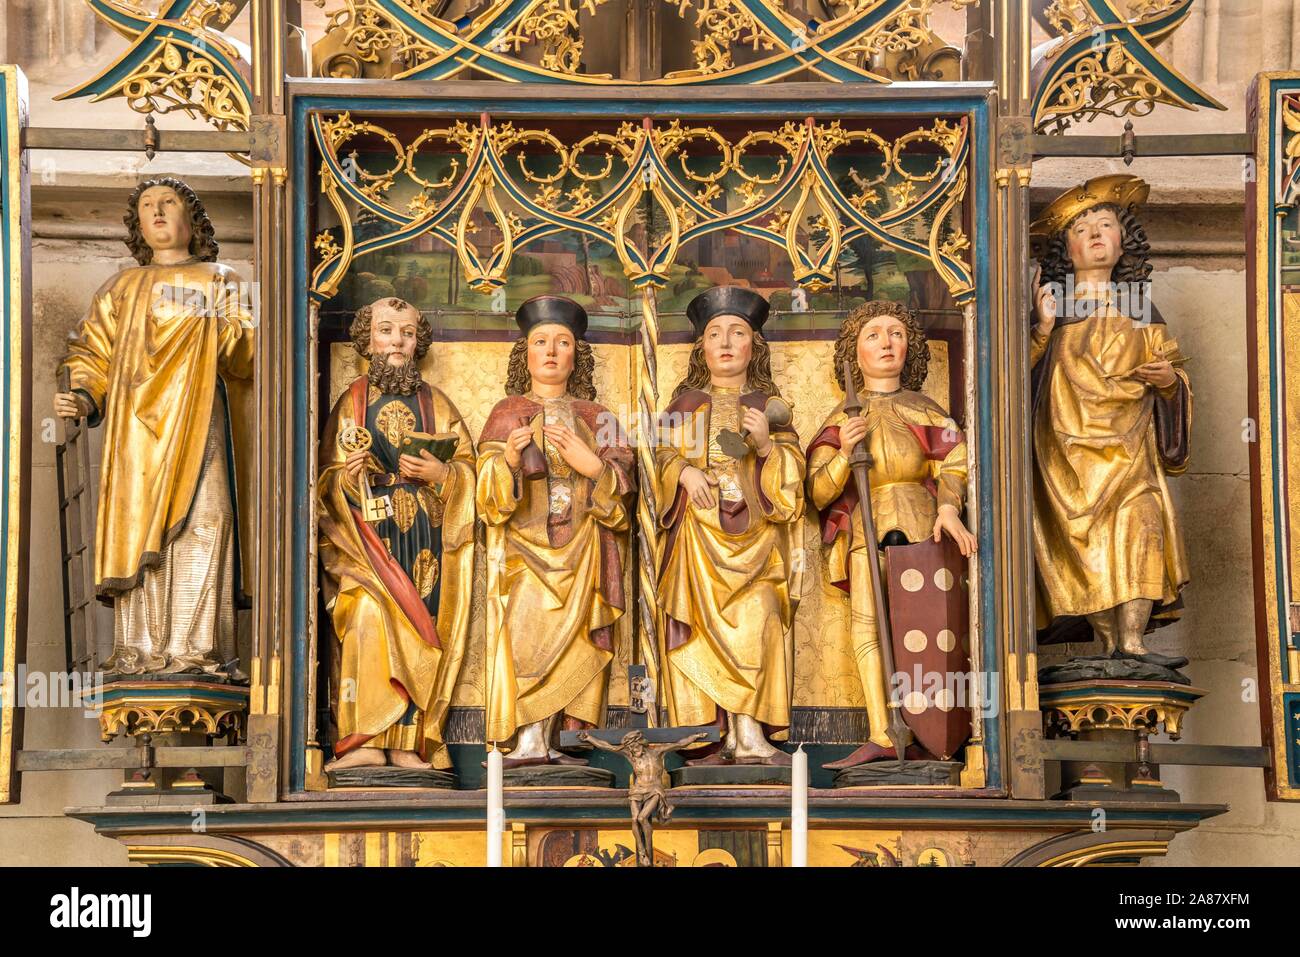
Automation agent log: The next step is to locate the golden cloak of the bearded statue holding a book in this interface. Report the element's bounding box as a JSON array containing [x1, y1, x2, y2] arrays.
[[317, 376, 475, 768]]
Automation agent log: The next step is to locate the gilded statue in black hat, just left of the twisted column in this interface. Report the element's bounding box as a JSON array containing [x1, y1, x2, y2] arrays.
[[478, 295, 633, 767]]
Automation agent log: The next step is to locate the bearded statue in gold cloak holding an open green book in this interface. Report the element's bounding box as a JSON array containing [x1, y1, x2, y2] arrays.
[[319, 298, 475, 770]]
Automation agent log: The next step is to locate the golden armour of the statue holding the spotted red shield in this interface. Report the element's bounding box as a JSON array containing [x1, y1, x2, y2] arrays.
[[807, 390, 966, 746]]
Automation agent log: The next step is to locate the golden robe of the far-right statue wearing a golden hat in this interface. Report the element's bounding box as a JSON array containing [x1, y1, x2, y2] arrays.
[[1031, 309, 1192, 627]]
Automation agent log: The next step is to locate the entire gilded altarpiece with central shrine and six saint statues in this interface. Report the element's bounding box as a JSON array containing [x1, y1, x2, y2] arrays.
[[0, 0, 1295, 866]]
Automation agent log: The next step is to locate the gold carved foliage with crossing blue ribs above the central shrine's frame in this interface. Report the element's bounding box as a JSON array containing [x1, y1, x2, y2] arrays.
[[313, 0, 975, 85]]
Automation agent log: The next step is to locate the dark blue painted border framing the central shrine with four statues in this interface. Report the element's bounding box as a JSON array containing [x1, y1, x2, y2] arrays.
[[283, 87, 1004, 790]]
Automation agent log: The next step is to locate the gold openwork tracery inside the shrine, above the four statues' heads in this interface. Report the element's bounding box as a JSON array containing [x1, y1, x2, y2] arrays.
[[312, 113, 974, 302]]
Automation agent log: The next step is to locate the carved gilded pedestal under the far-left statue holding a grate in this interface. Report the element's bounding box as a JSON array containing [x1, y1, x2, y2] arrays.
[[83, 675, 248, 807]]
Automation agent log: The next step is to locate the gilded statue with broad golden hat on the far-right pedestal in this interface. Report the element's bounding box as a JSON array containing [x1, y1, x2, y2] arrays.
[[1030, 174, 1192, 668]]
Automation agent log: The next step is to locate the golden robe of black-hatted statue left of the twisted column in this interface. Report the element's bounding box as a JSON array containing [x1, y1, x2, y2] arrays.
[[478, 395, 632, 742]]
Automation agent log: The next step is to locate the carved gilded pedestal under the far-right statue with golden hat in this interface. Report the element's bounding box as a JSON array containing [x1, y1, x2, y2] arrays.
[[1039, 679, 1205, 801]]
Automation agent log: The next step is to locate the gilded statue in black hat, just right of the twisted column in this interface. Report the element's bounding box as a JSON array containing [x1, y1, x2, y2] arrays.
[[655, 286, 803, 765]]
